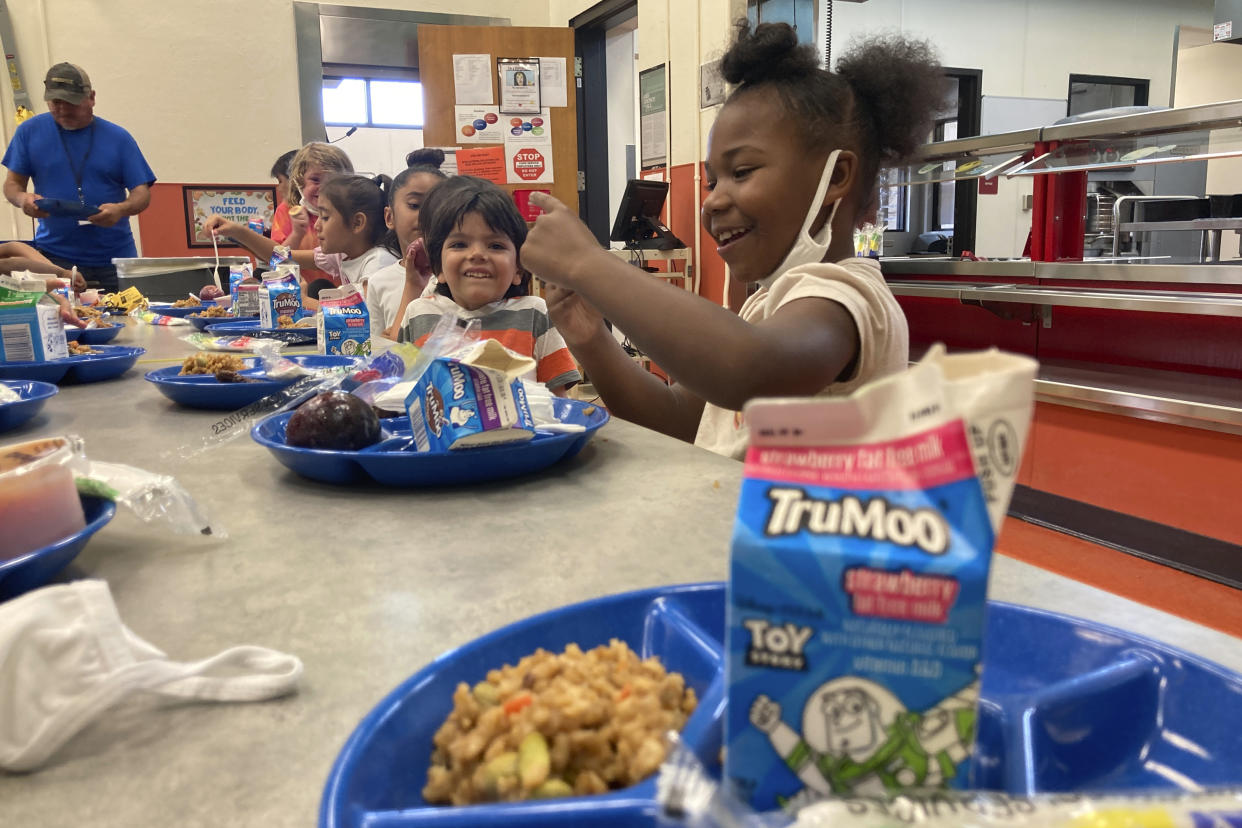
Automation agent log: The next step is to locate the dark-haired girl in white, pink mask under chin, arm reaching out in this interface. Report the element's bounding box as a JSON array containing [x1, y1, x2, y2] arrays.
[[204, 175, 397, 307]]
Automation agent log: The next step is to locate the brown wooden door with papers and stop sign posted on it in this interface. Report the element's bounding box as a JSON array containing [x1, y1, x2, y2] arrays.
[[419, 25, 578, 214]]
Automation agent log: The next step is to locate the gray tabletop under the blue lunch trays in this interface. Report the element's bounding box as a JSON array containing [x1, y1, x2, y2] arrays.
[[0, 325, 1242, 827]]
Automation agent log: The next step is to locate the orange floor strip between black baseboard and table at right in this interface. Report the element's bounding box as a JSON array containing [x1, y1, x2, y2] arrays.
[[996, 518, 1242, 636]]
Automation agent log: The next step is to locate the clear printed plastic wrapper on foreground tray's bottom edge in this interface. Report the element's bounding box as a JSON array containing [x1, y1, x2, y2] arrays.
[[656, 734, 1242, 828]]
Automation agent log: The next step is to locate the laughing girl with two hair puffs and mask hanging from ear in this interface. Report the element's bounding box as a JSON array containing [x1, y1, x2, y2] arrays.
[[522, 21, 946, 458]]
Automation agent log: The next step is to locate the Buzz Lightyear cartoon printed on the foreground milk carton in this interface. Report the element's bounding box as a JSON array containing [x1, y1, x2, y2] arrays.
[[750, 675, 979, 796]]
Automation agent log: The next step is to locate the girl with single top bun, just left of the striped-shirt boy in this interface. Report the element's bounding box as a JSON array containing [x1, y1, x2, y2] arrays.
[[366, 149, 447, 345]]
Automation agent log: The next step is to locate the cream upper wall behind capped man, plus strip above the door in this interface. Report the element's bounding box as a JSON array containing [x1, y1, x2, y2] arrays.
[[0, 0, 548, 237]]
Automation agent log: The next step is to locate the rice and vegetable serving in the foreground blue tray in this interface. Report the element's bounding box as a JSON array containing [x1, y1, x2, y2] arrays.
[[422, 638, 698, 806]]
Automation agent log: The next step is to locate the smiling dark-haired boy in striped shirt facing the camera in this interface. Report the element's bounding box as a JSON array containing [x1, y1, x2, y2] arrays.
[[399, 175, 582, 396]]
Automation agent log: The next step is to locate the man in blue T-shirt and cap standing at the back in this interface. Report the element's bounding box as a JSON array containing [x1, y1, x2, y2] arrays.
[[0, 63, 155, 290]]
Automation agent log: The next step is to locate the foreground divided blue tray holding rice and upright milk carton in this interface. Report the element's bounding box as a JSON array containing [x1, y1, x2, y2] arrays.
[[319, 583, 1242, 828]]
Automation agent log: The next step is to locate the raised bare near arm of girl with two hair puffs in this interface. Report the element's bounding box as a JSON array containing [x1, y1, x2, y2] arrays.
[[522, 192, 858, 418]]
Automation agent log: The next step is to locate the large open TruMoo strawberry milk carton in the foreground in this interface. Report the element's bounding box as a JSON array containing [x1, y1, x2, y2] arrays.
[[725, 346, 1036, 811]]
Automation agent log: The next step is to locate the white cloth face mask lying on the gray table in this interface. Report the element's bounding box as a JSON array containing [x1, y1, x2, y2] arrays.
[[0, 581, 302, 771]]
